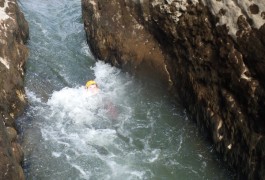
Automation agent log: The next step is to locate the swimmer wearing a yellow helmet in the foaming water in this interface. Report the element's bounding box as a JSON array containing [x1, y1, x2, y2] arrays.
[[86, 80, 118, 119]]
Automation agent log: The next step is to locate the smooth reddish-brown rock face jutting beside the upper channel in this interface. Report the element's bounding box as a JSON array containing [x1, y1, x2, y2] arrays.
[[82, 0, 168, 83]]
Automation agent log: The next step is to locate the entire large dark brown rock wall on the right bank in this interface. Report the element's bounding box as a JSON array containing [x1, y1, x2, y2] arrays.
[[82, 0, 265, 179]]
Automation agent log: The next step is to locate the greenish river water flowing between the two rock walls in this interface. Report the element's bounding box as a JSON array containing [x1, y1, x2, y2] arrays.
[[17, 0, 233, 180]]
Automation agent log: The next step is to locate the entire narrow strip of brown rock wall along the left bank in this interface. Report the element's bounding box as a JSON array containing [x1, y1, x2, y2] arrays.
[[0, 0, 29, 179]]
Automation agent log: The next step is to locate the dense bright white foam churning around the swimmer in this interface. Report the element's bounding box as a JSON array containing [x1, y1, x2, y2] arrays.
[[34, 62, 137, 179]]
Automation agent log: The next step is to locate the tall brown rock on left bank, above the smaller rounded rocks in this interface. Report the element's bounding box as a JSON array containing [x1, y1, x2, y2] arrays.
[[0, 0, 28, 126]]
